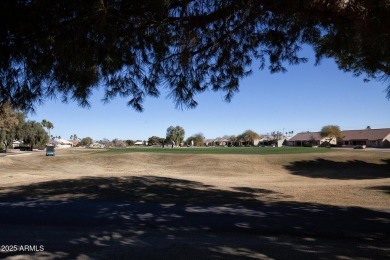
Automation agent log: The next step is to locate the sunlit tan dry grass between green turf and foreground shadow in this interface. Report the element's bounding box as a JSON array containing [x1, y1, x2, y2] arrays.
[[0, 149, 390, 208]]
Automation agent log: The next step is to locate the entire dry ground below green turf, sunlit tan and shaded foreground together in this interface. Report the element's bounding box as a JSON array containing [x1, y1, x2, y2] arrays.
[[0, 149, 390, 260]]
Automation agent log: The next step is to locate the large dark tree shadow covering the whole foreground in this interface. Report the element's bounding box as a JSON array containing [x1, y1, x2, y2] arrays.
[[0, 176, 390, 259]]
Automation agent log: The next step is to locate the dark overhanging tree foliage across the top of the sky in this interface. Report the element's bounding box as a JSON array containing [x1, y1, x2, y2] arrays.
[[0, 0, 390, 111]]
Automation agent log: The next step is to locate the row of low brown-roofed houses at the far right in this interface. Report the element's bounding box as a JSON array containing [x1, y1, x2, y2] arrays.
[[288, 128, 390, 148]]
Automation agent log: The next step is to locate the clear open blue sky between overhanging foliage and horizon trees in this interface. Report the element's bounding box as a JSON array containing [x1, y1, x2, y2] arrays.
[[28, 46, 390, 140]]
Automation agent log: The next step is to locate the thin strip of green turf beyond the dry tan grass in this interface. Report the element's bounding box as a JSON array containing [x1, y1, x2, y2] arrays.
[[103, 147, 337, 155]]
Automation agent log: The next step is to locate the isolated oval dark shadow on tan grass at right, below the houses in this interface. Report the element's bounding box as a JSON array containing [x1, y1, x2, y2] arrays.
[[285, 159, 390, 180]]
